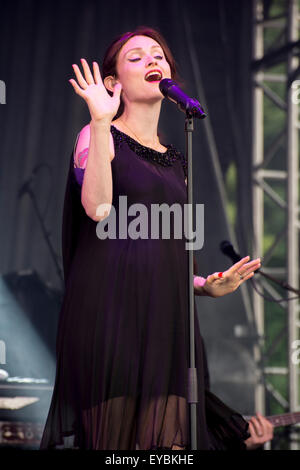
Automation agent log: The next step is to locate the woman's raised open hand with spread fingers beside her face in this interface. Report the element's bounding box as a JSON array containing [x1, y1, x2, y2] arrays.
[[69, 59, 122, 123]]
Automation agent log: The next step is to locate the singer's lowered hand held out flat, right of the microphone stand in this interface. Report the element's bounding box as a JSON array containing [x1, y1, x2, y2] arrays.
[[194, 256, 261, 297]]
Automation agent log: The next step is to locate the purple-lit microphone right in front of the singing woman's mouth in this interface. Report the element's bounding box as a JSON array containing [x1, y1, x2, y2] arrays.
[[159, 78, 207, 119]]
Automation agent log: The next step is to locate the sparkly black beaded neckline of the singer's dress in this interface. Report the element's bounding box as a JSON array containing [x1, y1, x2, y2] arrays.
[[111, 125, 184, 174]]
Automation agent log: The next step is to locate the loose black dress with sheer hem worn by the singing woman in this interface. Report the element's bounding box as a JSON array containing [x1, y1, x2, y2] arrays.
[[40, 125, 249, 450]]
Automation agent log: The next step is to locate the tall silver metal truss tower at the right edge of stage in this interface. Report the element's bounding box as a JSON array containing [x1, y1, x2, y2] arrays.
[[252, 0, 300, 449]]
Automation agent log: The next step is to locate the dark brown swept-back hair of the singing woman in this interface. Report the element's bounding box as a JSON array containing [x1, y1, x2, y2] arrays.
[[102, 26, 182, 119]]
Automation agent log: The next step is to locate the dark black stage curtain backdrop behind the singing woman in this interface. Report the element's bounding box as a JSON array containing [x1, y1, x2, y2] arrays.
[[0, 0, 254, 413]]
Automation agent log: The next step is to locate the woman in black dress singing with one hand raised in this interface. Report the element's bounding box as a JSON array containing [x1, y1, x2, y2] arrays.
[[41, 27, 260, 450]]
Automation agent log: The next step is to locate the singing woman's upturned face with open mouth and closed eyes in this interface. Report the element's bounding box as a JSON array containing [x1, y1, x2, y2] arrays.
[[117, 36, 171, 106]]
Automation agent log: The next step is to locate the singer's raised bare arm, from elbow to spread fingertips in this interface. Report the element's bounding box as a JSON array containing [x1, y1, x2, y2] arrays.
[[70, 59, 122, 221]]
